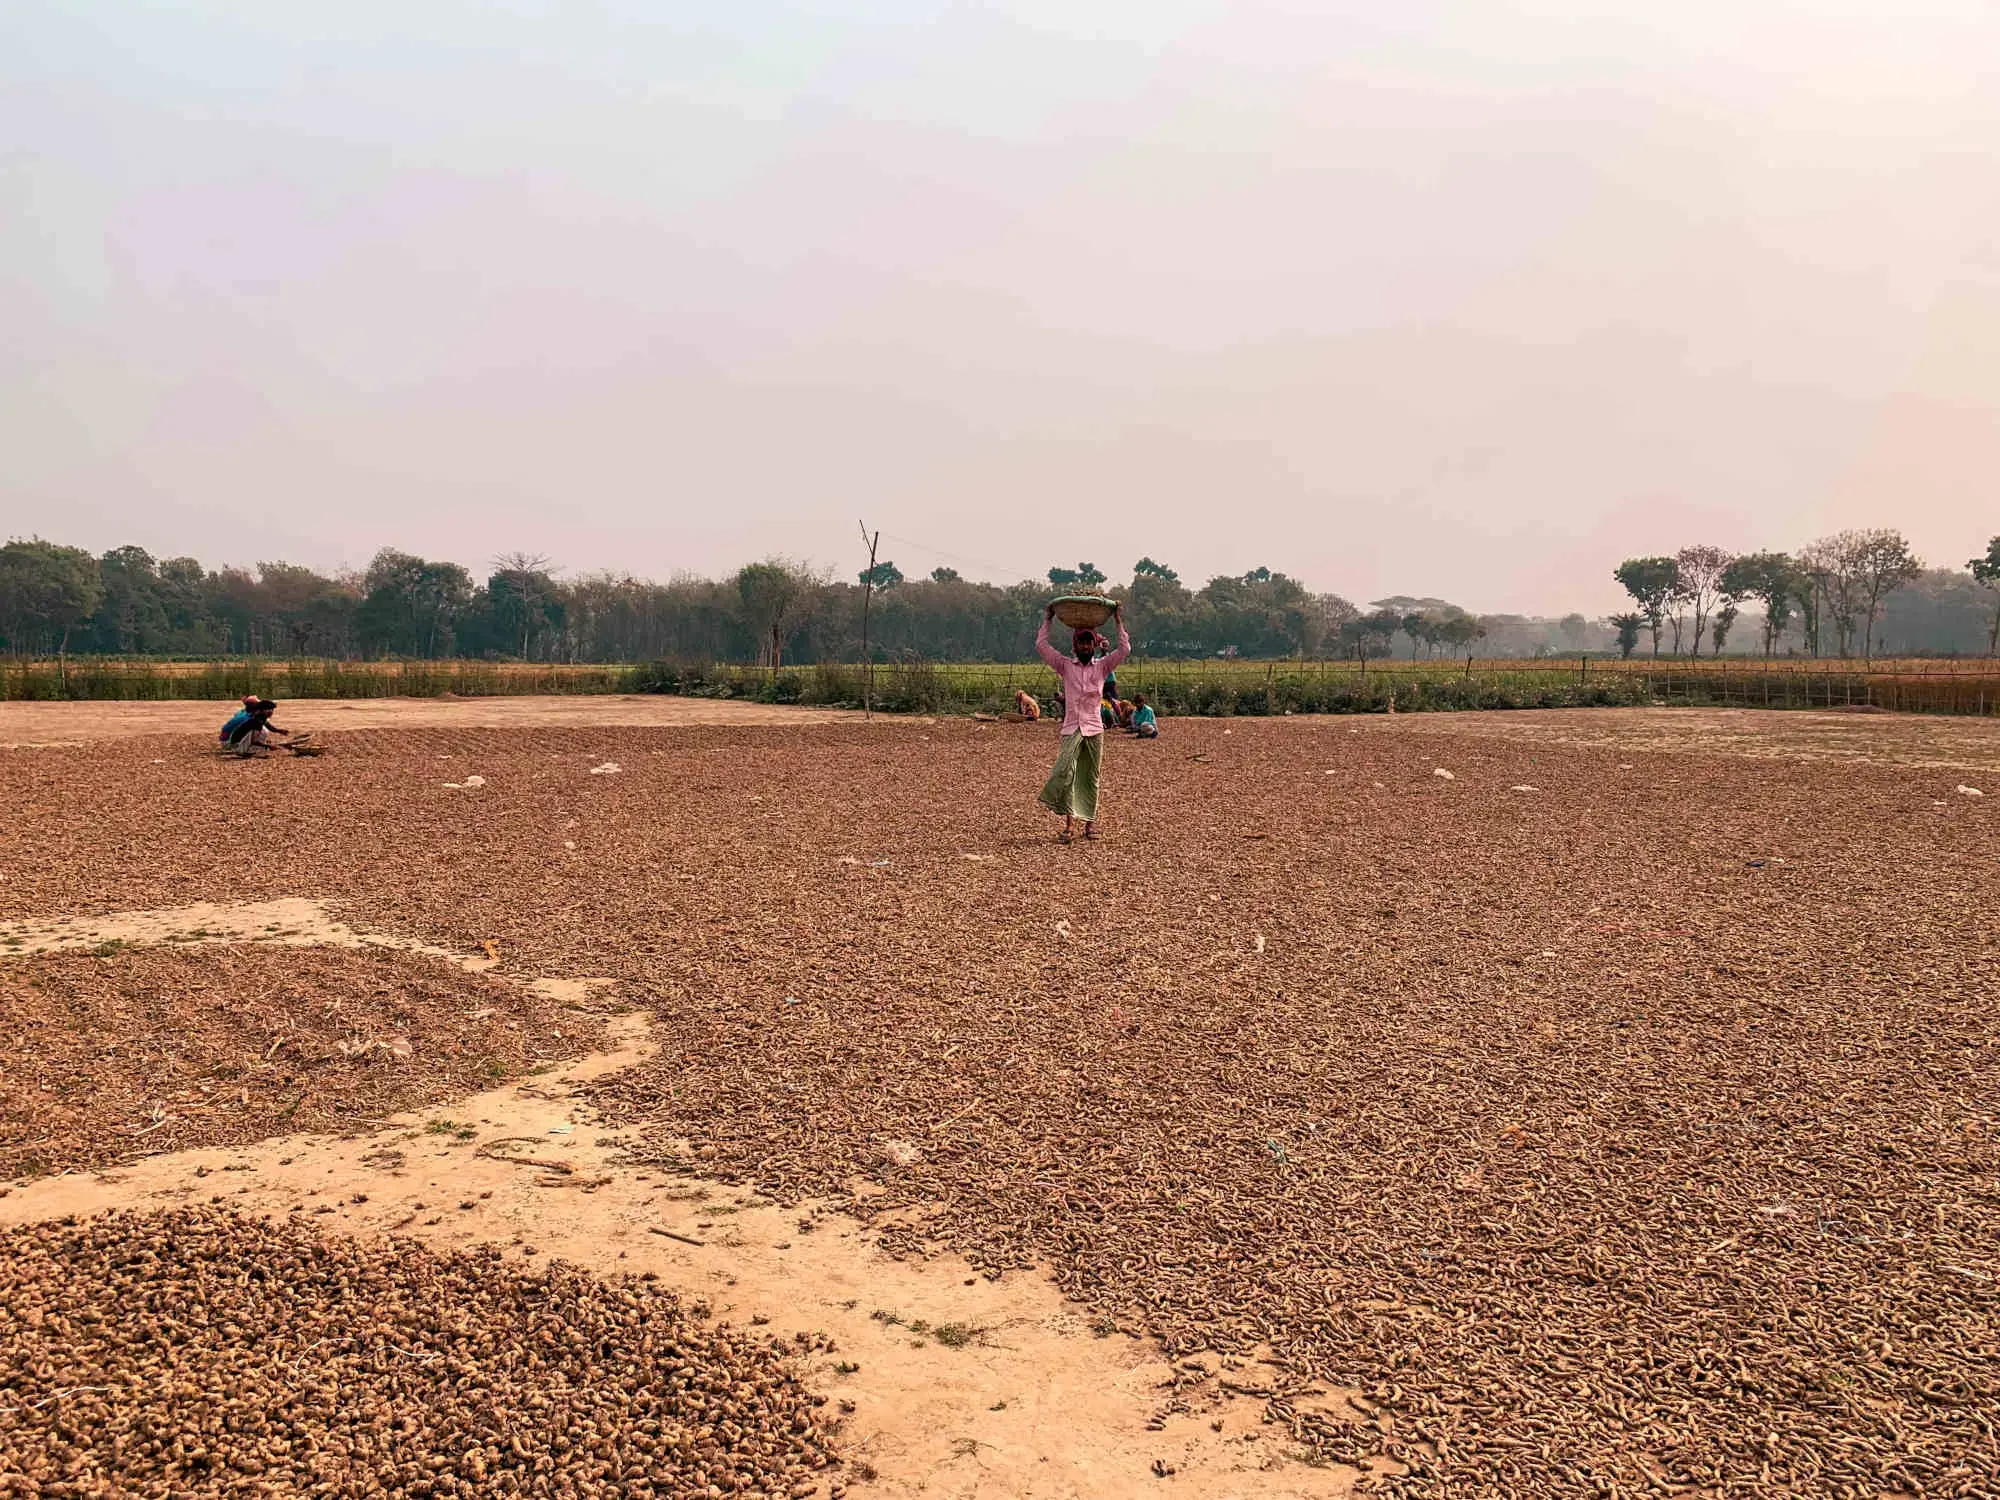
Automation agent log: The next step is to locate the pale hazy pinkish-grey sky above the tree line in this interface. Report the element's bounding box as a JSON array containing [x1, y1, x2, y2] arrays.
[[0, 0, 2000, 612]]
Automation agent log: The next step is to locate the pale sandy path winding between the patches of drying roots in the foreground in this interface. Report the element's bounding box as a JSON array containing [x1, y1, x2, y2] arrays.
[[0, 900, 1358, 1500]]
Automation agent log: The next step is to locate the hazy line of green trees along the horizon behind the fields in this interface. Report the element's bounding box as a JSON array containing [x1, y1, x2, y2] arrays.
[[0, 532, 2000, 666]]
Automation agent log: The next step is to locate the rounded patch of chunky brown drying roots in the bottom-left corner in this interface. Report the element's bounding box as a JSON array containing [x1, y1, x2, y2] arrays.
[[0, 1208, 830, 1500]]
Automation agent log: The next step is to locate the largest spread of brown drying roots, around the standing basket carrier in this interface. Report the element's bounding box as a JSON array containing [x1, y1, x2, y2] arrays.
[[0, 722, 2000, 1496]]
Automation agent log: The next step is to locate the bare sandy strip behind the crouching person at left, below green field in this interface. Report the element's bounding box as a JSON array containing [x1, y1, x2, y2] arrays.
[[0, 694, 914, 750]]
